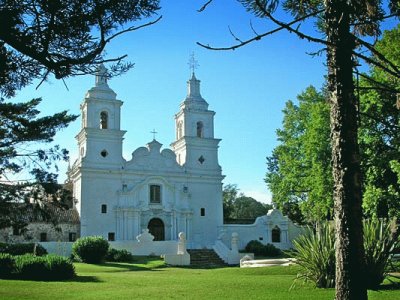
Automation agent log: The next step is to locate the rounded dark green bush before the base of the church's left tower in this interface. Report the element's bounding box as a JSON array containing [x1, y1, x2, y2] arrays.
[[72, 236, 110, 264]]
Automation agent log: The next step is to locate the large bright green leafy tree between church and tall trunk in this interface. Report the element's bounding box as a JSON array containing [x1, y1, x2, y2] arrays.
[[265, 86, 333, 224]]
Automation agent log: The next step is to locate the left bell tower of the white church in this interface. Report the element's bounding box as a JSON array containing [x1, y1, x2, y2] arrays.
[[76, 65, 125, 169]]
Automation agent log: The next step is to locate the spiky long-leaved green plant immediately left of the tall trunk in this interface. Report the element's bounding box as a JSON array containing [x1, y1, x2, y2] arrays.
[[293, 223, 335, 288]]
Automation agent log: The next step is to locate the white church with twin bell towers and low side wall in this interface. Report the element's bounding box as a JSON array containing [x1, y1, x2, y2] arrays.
[[69, 66, 298, 253]]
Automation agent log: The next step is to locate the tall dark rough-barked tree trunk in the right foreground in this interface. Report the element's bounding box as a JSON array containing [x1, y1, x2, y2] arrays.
[[325, 0, 367, 300]]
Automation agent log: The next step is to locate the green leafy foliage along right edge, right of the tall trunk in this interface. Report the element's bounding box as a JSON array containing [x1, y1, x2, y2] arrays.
[[359, 25, 400, 218]]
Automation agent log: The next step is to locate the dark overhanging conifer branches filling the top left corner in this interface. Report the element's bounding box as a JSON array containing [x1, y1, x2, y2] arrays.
[[0, 0, 159, 97]]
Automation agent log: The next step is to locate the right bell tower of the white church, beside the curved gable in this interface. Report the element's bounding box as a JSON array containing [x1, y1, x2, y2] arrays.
[[171, 65, 221, 174]]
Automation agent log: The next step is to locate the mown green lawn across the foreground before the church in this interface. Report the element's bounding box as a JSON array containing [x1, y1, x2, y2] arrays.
[[0, 259, 400, 300]]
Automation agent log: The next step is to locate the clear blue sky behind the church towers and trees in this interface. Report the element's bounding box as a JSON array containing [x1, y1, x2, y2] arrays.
[[10, 0, 396, 202]]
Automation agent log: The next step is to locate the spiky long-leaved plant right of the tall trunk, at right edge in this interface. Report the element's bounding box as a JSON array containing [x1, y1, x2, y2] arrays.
[[364, 219, 399, 289]]
